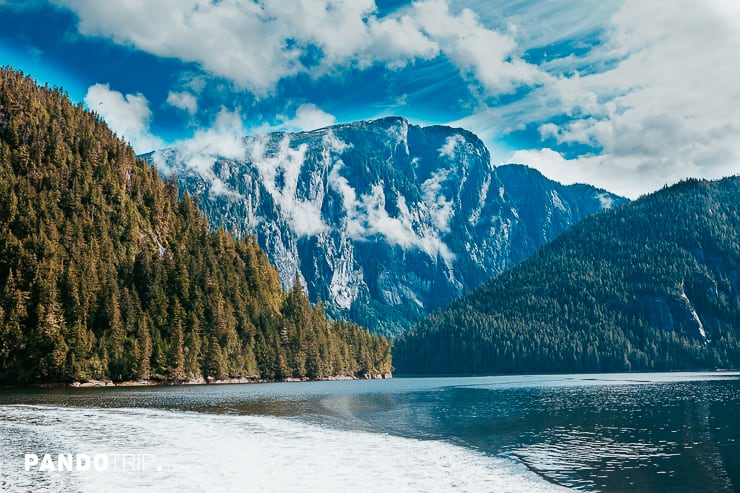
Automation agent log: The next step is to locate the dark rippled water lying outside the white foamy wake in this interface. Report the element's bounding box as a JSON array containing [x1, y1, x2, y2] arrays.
[[0, 373, 740, 492]]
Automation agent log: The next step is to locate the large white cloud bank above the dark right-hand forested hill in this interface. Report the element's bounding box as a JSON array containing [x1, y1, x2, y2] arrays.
[[498, 0, 740, 197]]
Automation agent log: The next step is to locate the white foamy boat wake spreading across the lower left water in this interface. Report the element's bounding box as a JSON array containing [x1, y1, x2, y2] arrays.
[[0, 405, 566, 493]]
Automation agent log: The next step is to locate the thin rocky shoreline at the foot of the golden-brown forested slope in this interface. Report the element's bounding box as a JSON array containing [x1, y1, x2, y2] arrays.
[[0, 372, 393, 389]]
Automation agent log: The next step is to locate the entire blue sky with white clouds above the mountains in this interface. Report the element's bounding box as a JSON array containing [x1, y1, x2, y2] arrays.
[[0, 0, 740, 198]]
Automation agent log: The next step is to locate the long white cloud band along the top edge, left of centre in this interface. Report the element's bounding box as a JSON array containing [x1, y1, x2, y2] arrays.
[[53, 0, 539, 96]]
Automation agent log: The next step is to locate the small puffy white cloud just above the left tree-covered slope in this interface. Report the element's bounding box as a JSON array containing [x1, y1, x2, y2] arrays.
[[85, 84, 164, 154]]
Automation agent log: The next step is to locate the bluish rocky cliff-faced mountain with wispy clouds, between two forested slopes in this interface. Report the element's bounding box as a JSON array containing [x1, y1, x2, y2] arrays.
[[155, 117, 624, 334]]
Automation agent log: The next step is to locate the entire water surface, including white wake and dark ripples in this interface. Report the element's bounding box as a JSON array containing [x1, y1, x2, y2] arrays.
[[0, 373, 740, 492]]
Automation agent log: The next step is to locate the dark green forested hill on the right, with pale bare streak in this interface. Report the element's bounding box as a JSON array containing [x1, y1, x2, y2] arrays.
[[393, 176, 740, 373]]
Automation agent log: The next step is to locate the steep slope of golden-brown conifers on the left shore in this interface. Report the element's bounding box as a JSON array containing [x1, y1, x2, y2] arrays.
[[0, 69, 391, 384]]
